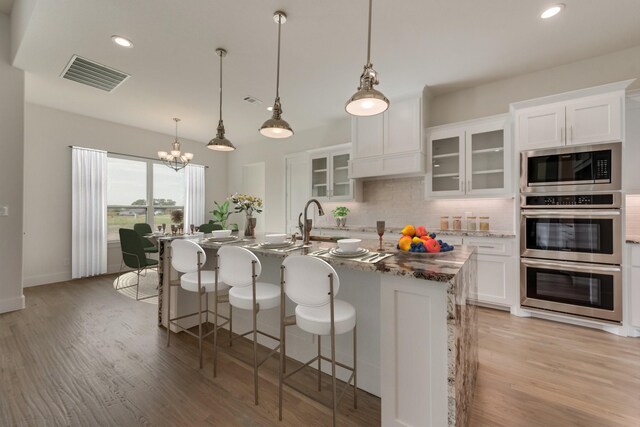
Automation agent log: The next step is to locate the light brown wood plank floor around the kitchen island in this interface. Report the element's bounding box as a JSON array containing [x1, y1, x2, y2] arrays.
[[0, 276, 640, 427]]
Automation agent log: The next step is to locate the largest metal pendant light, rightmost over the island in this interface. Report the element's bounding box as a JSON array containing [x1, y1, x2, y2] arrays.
[[345, 0, 389, 116]]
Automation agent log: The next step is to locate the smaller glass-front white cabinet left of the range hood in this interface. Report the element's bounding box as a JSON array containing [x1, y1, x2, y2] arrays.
[[311, 149, 353, 200]]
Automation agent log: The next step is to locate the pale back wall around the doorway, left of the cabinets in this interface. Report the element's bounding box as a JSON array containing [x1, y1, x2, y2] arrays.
[[227, 118, 351, 232]]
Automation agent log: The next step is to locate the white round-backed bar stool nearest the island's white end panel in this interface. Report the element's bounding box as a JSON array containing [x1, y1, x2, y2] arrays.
[[278, 255, 358, 426]]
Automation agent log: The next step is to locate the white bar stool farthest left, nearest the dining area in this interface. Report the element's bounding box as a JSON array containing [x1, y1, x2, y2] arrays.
[[167, 240, 229, 369]]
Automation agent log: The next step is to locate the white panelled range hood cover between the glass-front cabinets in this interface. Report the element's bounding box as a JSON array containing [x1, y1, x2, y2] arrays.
[[350, 97, 424, 178]]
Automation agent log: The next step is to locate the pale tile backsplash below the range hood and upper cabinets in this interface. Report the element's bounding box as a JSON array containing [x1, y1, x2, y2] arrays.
[[316, 177, 516, 233]]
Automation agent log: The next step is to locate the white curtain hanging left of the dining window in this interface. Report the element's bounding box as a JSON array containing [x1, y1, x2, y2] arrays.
[[71, 147, 107, 279]]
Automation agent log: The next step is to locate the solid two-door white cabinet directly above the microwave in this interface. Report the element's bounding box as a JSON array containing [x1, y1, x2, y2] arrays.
[[516, 93, 623, 150]]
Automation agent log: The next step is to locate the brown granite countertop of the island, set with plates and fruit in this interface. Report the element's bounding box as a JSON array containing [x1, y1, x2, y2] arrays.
[[159, 235, 475, 284]]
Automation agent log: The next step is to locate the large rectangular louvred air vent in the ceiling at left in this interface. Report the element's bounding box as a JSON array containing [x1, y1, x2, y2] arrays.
[[62, 55, 130, 92]]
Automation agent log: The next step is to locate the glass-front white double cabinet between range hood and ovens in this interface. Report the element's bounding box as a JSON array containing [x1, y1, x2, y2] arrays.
[[426, 115, 512, 198]]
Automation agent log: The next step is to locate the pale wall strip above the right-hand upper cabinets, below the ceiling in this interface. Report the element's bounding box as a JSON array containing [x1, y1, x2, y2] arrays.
[[429, 45, 640, 126]]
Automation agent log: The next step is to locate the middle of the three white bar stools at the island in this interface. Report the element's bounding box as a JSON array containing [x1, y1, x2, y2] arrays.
[[218, 246, 280, 405]]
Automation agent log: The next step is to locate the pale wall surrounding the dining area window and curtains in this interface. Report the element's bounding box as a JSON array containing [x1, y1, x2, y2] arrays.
[[23, 104, 228, 286]]
